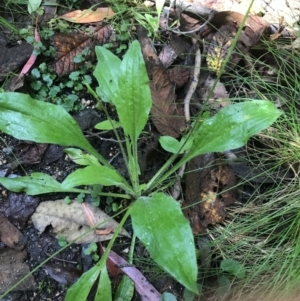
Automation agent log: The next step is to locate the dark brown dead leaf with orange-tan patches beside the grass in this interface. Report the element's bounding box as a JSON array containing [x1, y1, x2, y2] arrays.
[[184, 153, 238, 234]]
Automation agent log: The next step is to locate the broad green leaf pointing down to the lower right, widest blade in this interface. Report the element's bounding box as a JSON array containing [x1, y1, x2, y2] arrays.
[[131, 193, 198, 293]]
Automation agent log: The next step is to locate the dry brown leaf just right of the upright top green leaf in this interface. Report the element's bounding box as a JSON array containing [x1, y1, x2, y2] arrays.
[[150, 67, 186, 138]]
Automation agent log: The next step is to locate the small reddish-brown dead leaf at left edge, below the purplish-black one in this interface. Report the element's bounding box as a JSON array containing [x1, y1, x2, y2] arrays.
[[0, 216, 25, 250]]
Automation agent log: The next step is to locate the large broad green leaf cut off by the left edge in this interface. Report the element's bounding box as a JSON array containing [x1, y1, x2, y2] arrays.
[[0, 92, 99, 160]]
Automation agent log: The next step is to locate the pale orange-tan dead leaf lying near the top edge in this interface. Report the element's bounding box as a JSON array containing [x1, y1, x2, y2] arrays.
[[60, 7, 115, 23]]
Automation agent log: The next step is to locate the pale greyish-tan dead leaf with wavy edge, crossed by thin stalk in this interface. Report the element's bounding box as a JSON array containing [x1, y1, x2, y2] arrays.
[[31, 200, 130, 244]]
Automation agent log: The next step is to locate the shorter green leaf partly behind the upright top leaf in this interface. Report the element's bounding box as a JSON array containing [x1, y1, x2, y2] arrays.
[[93, 46, 121, 103]]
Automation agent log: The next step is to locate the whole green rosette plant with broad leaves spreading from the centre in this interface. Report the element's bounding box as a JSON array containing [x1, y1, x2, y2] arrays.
[[0, 41, 281, 301]]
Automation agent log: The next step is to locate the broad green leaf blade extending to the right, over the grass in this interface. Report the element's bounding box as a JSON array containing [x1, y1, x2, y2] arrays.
[[184, 100, 282, 161]]
